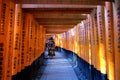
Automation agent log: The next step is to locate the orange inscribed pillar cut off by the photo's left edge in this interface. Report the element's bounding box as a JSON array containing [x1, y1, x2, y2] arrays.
[[0, 0, 9, 80]]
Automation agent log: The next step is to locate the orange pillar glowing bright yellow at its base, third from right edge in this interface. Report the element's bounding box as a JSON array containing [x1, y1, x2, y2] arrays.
[[97, 6, 106, 80]]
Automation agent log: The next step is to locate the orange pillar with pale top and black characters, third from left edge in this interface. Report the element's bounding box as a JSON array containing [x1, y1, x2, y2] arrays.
[[12, 4, 21, 75]]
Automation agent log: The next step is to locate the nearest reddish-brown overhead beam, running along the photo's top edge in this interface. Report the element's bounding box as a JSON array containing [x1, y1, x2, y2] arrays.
[[15, 0, 113, 5]]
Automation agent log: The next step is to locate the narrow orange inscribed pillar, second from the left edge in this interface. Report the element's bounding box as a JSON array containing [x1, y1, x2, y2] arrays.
[[5, 1, 15, 80]]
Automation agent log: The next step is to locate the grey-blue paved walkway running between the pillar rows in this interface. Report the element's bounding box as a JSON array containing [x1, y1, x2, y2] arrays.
[[35, 52, 78, 80]]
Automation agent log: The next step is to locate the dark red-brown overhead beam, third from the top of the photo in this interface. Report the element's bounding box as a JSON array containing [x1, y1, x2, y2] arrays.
[[23, 8, 93, 14]]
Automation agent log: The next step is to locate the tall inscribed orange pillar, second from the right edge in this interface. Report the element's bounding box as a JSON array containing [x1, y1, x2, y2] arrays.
[[105, 2, 115, 80]]
